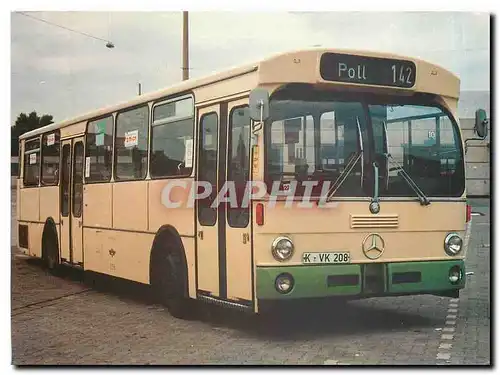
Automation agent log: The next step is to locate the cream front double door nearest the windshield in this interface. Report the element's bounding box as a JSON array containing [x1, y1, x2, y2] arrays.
[[196, 100, 253, 307]]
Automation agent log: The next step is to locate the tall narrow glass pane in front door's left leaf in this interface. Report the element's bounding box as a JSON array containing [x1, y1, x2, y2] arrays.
[[198, 112, 219, 226]]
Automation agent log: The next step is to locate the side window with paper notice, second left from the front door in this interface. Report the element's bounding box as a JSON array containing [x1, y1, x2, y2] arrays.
[[115, 106, 149, 180]]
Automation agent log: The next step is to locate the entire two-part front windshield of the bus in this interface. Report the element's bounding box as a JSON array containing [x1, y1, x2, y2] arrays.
[[265, 89, 465, 197]]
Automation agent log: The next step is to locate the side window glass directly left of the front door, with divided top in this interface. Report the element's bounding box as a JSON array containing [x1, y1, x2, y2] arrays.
[[150, 98, 194, 177]]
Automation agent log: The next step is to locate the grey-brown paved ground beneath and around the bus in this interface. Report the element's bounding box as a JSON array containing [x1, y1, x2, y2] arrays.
[[12, 189, 491, 365]]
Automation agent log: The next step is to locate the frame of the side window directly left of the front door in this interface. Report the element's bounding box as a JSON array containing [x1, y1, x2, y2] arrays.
[[147, 92, 197, 180]]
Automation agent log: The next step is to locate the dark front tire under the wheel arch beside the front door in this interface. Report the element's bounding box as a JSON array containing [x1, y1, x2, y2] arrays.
[[151, 248, 195, 320]]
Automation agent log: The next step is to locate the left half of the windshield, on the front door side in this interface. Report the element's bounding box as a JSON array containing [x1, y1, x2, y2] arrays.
[[266, 98, 368, 196]]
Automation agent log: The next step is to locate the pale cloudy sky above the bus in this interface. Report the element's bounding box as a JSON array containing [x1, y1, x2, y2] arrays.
[[11, 11, 490, 124]]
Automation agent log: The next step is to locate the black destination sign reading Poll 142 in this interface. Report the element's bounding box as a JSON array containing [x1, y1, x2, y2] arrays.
[[319, 53, 417, 88]]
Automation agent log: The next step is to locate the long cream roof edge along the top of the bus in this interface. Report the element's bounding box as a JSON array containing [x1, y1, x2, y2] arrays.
[[19, 48, 459, 139]]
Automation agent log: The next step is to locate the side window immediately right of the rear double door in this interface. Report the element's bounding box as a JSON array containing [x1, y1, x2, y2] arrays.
[[85, 116, 113, 182]]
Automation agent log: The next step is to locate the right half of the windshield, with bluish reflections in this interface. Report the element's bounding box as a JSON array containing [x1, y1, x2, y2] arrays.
[[369, 104, 464, 197]]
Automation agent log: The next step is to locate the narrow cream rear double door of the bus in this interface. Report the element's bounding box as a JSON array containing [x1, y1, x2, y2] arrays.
[[60, 138, 84, 266]]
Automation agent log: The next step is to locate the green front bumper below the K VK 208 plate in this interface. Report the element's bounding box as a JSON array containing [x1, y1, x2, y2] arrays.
[[256, 259, 465, 300]]
